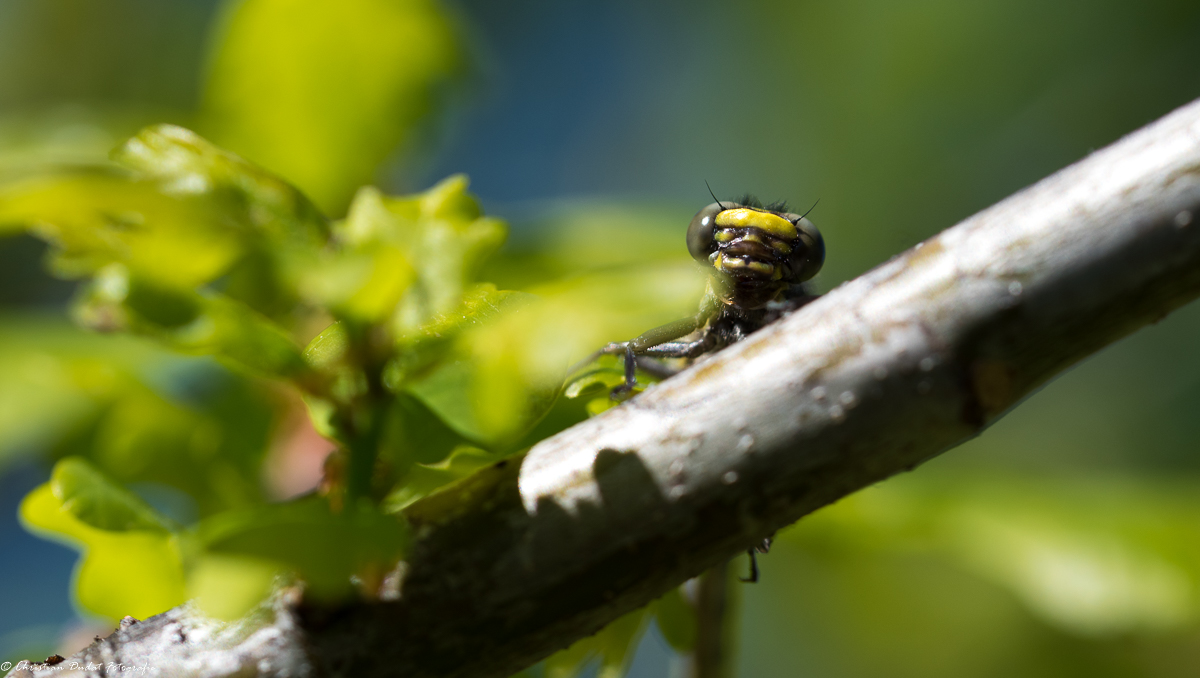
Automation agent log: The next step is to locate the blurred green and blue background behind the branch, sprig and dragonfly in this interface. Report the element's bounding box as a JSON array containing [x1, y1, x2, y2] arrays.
[[0, 0, 1200, 678]]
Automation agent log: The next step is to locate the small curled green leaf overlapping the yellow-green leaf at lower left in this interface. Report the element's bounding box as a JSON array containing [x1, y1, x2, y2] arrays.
[[49, 457, 170, 532]]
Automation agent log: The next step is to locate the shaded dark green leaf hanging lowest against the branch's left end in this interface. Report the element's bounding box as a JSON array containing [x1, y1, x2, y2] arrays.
[[197, 497, 408, 598]]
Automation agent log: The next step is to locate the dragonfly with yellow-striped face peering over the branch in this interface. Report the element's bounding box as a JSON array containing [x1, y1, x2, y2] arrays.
[[572, 188, 824, 582]]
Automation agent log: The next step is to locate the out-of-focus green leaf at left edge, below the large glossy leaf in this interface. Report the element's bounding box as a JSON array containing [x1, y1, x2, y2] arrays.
[[0, 314, 274, 515]]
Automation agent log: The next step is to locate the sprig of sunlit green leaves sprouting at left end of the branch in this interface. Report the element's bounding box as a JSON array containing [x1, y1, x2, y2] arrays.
[[0, 126, 562, 617]]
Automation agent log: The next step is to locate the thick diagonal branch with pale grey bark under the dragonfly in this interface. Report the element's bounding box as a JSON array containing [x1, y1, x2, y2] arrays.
[[11, 102, 1200, 678]]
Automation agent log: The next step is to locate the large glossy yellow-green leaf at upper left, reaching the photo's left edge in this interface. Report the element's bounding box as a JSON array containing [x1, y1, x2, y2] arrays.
[[0, 125, 338, 319]]
